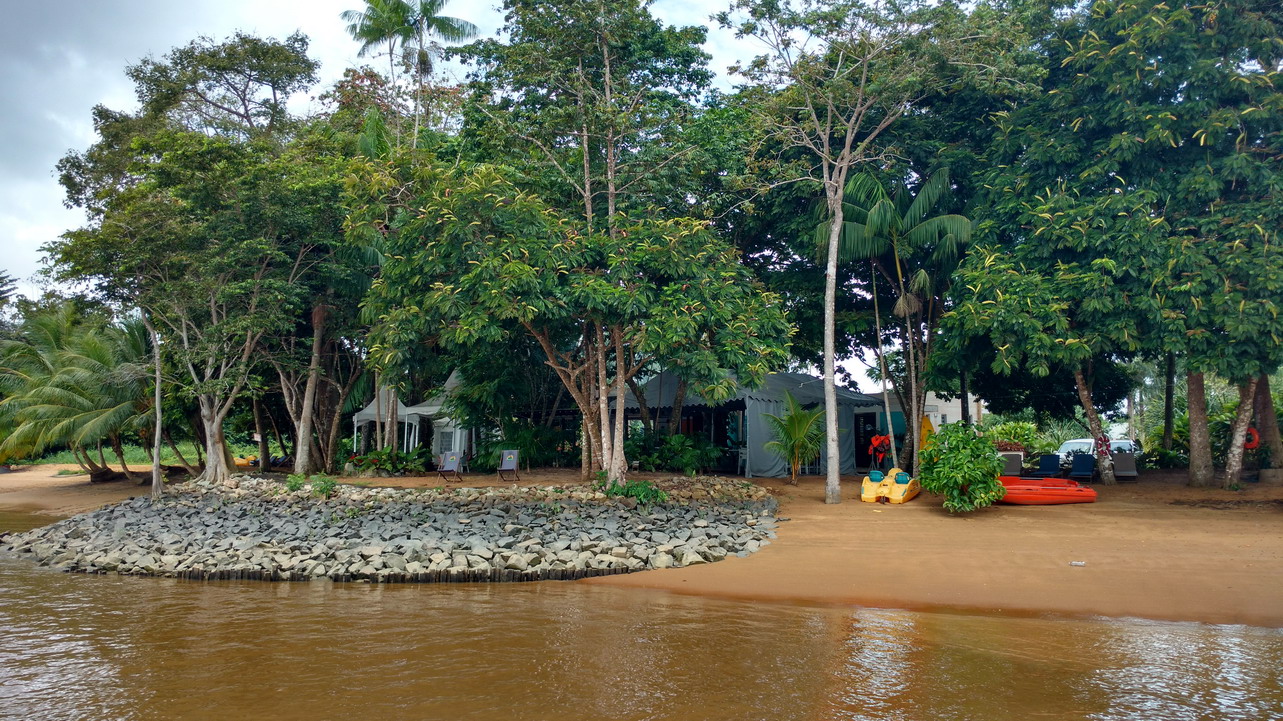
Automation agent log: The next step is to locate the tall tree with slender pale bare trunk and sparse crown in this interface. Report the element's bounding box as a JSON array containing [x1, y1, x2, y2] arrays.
[[718, 0, 1024, 503]]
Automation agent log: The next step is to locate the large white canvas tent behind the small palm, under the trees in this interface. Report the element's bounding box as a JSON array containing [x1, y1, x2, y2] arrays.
[[624, 371, 883, 477]]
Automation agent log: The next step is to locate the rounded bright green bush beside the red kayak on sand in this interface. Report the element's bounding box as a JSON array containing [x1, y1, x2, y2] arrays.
[[920, 421, 1005, 513]]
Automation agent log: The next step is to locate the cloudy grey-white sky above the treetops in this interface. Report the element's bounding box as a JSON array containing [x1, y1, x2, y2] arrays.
[[0, 0, 753, 295]]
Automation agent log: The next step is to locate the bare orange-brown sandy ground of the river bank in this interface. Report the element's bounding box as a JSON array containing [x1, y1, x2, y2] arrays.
[[0, 466, 1283, 626]]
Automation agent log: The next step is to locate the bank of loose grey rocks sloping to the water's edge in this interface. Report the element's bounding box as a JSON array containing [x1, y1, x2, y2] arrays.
[[0, 476, 777, 582]]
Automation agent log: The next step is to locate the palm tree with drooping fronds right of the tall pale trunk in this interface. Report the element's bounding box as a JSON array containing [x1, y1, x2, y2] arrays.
[[816, 168, 971, 475]]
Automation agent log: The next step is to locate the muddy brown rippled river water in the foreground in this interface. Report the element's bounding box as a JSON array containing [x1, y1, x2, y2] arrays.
[[0, 513, 1283, 721]]
